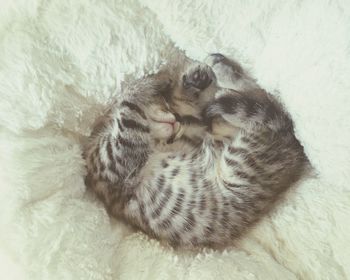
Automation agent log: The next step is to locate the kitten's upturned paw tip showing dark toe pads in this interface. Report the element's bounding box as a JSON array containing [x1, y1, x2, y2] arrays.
[[182, 64, 213, 90]]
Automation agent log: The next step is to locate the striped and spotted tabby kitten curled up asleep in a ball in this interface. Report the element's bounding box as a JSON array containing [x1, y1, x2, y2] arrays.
[[85, 54, 307, 247]]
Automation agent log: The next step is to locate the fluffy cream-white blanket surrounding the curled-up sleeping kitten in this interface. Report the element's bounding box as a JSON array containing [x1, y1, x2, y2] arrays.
[[0, 0, 350, 280]]
